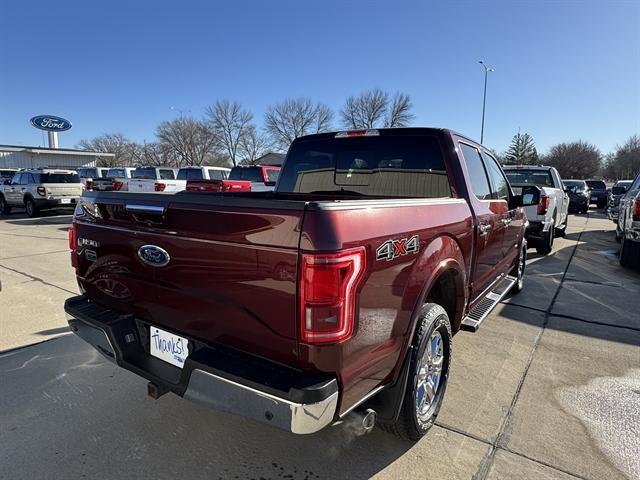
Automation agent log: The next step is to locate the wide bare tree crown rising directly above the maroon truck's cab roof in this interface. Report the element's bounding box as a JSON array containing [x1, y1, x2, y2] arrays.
[[340, 88, 414, 129]]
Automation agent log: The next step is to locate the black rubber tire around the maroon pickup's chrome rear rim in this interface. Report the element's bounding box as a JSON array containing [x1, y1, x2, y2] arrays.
[[378, 303, 451, 441]]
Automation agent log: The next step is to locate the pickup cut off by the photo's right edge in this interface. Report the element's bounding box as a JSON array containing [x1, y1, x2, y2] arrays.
[[616, 173, 640, 267]]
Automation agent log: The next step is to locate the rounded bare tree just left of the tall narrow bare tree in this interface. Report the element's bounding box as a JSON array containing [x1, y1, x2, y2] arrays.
[[156, 117, 219, 166]]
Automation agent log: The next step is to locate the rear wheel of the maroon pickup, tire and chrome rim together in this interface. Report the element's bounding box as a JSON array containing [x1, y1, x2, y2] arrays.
[[379, 303, 451, 441]]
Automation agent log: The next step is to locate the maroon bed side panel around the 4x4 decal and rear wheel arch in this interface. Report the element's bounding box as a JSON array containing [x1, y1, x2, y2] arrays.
[[300, 199, 473, 412]]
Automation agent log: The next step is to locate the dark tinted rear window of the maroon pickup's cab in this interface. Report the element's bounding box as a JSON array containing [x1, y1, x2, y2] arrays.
[[277, 135, 451, 198]]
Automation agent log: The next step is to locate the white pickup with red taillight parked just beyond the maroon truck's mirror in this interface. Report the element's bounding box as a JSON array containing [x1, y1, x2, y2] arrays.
[[504, 165, 569, 255]]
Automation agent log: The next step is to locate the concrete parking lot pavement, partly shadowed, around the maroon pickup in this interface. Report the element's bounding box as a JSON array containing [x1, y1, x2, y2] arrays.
[[0, 210, 640, 480]]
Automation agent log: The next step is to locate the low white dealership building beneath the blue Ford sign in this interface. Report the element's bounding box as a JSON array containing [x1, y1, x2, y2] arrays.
[[0, 145, 114, 169]]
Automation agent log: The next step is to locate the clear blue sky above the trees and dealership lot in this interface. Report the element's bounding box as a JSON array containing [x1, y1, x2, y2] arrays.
[[0, 0, 640, 153]]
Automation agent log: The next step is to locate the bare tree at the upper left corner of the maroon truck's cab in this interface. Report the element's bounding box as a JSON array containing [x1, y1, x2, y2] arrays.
[[264, 98, 333, 150]]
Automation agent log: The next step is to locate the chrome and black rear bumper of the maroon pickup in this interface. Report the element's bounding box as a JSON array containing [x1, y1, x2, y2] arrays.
[[65, 295, 339, 434]]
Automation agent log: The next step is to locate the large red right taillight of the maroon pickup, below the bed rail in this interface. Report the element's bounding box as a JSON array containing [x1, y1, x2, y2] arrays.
[[299, 247, 365, 343]]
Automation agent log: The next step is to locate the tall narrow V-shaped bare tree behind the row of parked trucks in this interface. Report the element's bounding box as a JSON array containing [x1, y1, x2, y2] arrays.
[[206, 99, 253, 165]]
